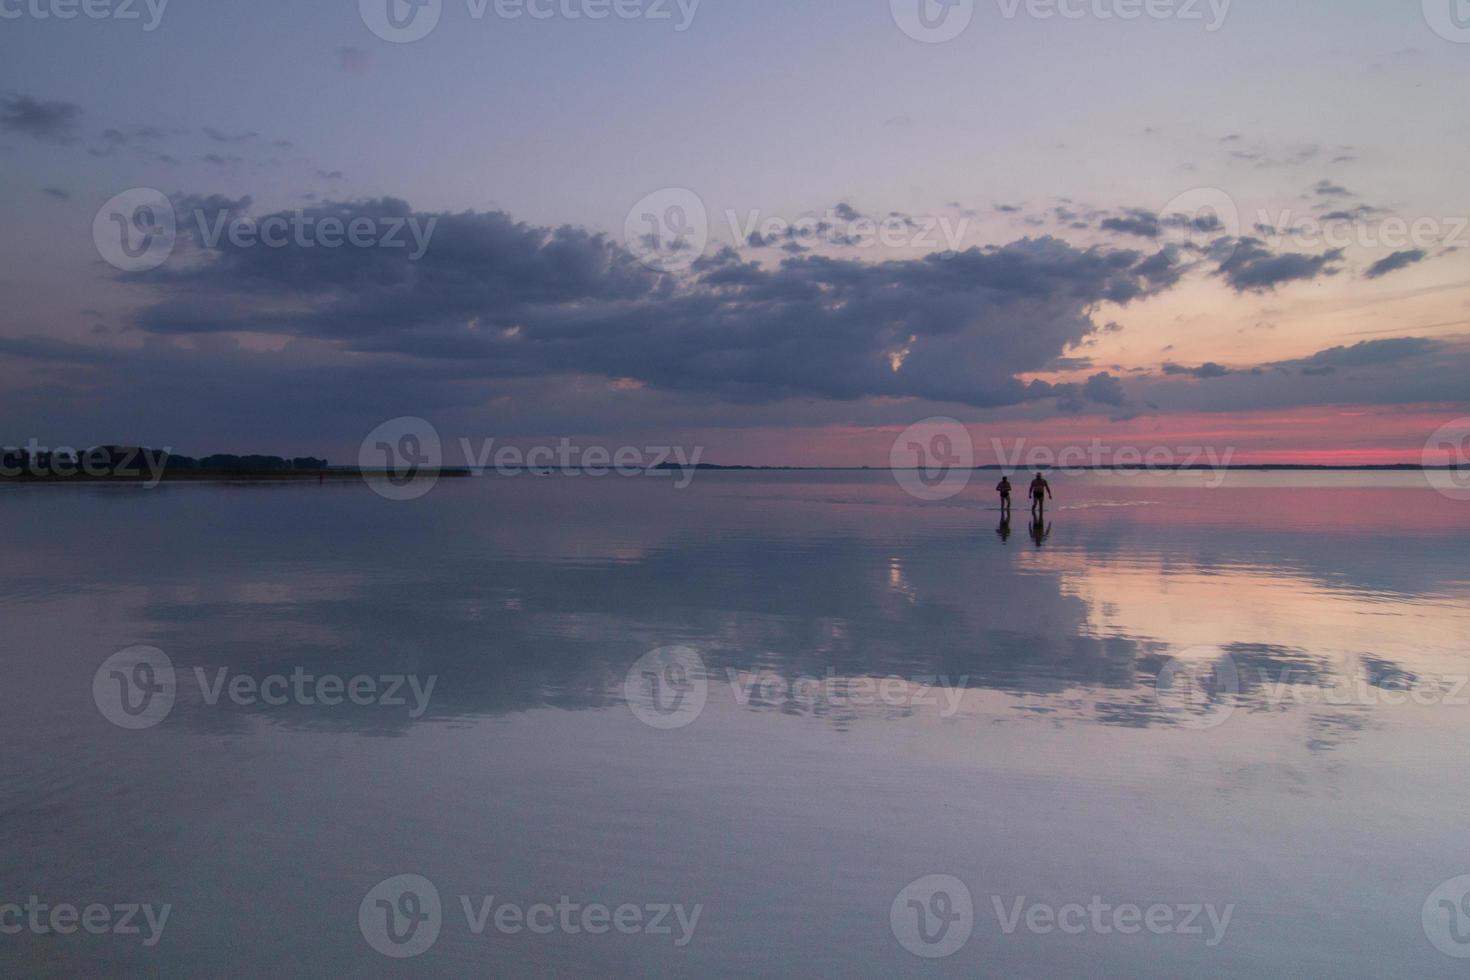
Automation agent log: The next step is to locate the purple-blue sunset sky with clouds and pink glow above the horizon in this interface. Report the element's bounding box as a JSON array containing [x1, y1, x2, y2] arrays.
[[0, 0, 1470, 466]]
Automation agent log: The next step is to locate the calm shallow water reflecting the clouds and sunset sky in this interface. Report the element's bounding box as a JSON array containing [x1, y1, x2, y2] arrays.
[[0, 473, 1470, 977]]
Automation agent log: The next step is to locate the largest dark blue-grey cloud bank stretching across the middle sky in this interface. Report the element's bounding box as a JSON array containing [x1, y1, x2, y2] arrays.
[[125, 197, 1164, 406]]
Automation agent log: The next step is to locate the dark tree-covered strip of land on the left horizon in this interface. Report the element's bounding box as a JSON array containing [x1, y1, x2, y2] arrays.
[[0, 445, 469, 483]]
